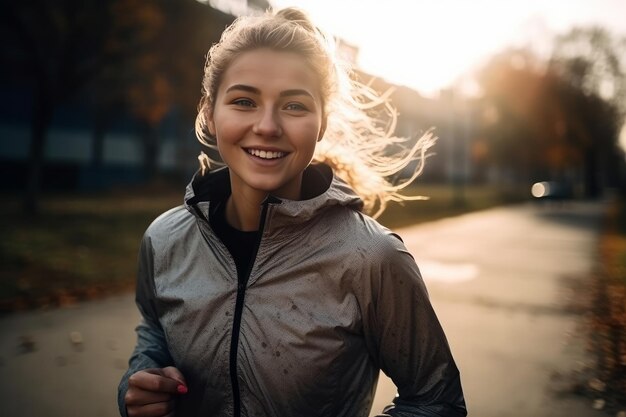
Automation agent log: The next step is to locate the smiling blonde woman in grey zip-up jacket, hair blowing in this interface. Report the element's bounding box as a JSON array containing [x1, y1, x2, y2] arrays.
[[119, 9, 466, 417]]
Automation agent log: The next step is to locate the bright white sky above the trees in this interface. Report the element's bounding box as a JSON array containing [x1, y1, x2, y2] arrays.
[[271, 0, 626, 97]]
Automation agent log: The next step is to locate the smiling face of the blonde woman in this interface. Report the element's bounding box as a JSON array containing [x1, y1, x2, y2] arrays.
[[208, 49, 325, 200]]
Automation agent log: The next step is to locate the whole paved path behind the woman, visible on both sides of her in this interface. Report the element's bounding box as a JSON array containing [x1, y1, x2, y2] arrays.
[[0, 203, 602, 417]]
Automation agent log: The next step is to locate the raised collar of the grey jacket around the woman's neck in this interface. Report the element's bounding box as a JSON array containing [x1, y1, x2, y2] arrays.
[[185, 164, 363, 227]]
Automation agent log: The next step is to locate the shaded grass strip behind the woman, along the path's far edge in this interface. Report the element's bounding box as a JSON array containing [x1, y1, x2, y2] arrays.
[[0, 180, 524, 311]]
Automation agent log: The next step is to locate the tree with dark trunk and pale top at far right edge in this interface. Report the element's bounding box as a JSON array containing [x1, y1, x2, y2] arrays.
[[550, 27, 626, 195]]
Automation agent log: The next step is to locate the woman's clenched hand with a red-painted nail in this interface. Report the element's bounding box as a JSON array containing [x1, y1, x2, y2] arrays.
[[124, 366, 187, 417]]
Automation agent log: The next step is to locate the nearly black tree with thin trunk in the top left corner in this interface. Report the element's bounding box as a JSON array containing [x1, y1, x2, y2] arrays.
[[0, 0, 111, 213]]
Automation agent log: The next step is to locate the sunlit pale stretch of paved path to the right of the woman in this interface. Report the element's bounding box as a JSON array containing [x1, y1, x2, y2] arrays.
[[373, 203, 603, 417]]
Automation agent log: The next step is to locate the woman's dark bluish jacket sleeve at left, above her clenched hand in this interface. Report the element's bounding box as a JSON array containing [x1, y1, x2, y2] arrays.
[[117, 234, 173, 417]]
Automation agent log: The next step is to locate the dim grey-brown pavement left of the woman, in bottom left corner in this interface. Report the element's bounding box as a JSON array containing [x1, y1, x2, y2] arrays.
[[0, 294, 139, 417]]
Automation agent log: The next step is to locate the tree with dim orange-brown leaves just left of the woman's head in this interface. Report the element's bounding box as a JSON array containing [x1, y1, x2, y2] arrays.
[[94, 0, 234, 179]]
